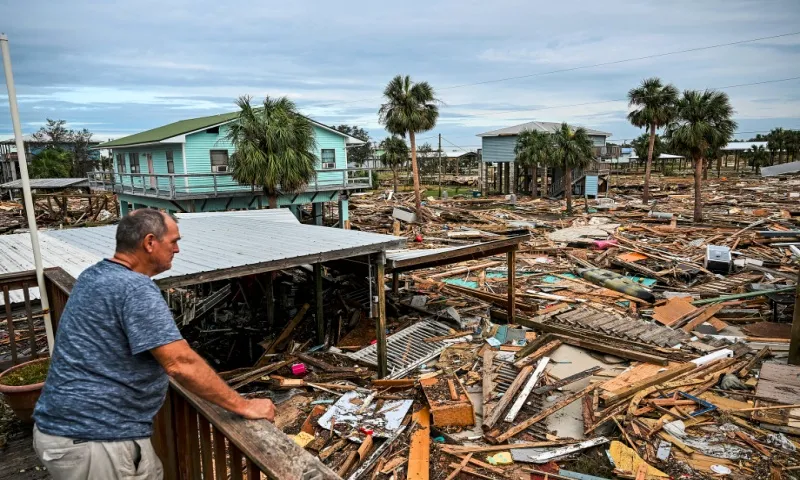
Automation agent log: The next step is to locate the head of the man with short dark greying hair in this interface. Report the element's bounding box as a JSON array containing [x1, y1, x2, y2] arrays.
[[116, 209, 181, 276]]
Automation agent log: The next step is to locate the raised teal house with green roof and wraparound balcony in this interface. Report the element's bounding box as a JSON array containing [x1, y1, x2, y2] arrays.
[[89, 113, 371, 228]]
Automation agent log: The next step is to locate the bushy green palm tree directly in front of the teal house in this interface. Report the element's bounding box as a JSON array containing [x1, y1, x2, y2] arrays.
[[227, 96, 317, 208]]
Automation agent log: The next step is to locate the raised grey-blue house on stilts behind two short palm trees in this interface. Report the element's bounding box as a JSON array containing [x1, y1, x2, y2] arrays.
[[478, 122, 620, 197]]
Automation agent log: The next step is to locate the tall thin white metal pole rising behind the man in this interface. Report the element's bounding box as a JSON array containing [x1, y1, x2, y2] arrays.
[[0, 33, 54, 355]]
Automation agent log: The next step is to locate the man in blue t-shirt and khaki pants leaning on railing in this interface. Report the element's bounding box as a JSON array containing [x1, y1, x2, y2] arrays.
[[33, 209, 275, 480]]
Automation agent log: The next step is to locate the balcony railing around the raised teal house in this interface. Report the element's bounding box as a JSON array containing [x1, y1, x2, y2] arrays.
[[88, 169, 372, 200]]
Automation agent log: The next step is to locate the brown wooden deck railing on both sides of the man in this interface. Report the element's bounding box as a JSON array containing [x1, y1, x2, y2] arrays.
[[0, 268, 339, 480]]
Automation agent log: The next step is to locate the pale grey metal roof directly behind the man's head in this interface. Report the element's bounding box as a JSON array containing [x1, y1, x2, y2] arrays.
[[0, 209, 406, 301]]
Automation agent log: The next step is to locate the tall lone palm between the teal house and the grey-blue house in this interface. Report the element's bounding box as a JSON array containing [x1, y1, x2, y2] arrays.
[[378, 75, 439, 215]]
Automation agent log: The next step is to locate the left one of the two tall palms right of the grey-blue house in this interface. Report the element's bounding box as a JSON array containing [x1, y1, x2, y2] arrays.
[[628, 77, 678, 203]]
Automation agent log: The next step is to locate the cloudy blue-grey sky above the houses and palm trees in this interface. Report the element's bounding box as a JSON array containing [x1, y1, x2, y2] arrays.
[[0, 0, 800, 151]]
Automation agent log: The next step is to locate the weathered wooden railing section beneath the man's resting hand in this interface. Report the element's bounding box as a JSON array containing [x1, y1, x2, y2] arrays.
[[152, 381, 339, 480]]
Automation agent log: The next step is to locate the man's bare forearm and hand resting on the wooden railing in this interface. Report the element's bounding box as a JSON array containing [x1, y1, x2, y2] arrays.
[[150, 340, 275, 421]]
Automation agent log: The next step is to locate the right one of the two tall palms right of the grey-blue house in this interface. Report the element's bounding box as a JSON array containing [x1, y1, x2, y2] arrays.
[[666, 90, 736, 222]]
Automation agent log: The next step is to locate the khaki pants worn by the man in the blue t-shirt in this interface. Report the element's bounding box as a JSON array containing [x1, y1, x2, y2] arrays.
[[33, 426, 164, 480]]
